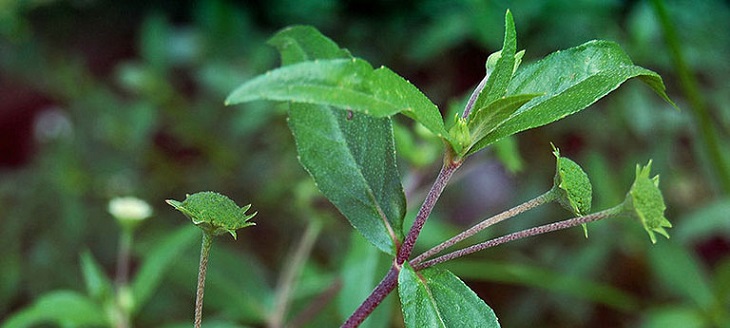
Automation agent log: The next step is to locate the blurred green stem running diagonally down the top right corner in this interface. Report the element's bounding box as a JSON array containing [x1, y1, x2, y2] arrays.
[[652, 0, 730, 194]]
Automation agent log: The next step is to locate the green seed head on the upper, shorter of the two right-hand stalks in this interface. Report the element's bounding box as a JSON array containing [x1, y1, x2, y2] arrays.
[[551, 144, 593, 217]]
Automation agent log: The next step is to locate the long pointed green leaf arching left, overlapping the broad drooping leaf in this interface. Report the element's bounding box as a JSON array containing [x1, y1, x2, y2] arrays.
[[226, 58, 448, 138]]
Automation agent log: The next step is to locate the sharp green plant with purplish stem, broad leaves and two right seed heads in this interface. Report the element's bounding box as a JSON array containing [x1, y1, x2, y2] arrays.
[[226, 11, 672, 327]]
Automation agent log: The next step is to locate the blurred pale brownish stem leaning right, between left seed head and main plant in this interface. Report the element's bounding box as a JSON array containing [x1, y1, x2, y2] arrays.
[[268, 219, 322, 328]]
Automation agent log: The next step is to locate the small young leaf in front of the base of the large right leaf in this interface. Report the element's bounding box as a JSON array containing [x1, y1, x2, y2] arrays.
[[466, 94, 540, 155]]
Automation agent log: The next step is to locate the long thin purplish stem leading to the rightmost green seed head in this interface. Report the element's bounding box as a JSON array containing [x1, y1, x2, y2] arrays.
[[412, 204, 624, 271]]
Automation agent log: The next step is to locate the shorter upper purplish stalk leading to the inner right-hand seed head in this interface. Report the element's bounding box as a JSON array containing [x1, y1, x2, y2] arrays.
[[410, 188, 557, 265]]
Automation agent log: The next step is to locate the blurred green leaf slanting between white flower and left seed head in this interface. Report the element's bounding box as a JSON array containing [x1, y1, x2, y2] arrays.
[[132, 225, 200, 310]]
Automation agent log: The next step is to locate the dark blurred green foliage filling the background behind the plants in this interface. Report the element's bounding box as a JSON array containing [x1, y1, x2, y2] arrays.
[[0, 0, 730, 327]]
